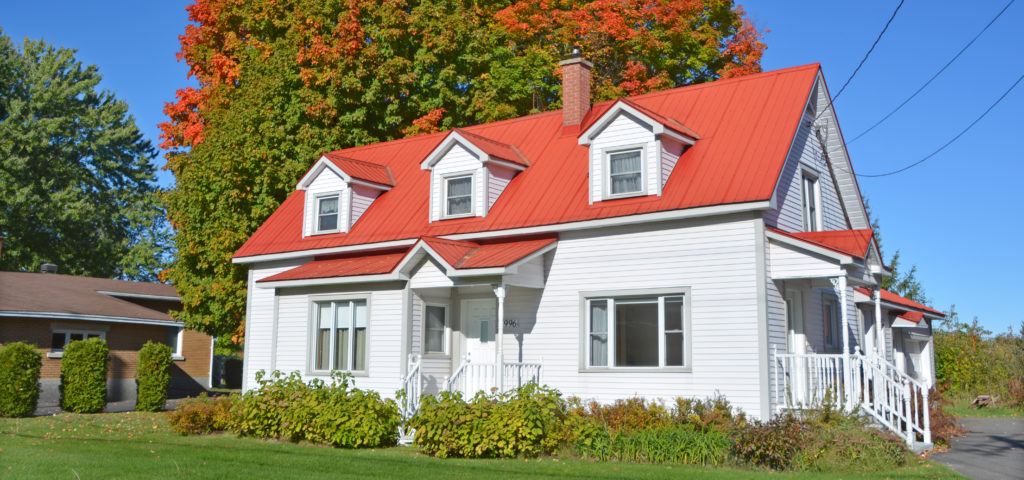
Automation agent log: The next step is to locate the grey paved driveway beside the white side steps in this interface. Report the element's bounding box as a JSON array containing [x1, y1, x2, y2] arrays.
[[932, 419, 1024, 480]]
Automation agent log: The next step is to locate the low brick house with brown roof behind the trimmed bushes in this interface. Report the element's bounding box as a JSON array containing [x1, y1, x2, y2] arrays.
[[0, 271, 213, 405]]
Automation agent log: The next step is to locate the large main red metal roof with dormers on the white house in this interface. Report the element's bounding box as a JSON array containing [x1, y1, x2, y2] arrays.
[[234, 64, 819, 257]]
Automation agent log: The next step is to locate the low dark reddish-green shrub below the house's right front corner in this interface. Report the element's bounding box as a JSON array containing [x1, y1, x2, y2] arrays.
[[732, 414, 809, 470]]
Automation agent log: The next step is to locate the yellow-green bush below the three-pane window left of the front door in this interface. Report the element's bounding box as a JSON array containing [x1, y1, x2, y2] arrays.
[[230, 372, 400, 448]]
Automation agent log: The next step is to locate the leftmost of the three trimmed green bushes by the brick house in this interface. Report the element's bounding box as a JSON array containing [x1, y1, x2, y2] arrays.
[[0, 342, 43, 417]]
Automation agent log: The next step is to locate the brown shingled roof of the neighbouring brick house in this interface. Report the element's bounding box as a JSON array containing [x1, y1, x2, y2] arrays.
[[0, 271, 180, 321]]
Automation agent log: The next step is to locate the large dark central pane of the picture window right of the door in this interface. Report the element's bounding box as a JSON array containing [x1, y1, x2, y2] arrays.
[[614, 298, 658, 366]]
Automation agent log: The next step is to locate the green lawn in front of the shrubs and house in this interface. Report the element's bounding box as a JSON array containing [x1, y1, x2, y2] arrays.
[[0, 413, 959, 480]]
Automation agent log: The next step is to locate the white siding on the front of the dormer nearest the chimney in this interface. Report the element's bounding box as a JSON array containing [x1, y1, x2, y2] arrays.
[[590, 114, 662, 203]]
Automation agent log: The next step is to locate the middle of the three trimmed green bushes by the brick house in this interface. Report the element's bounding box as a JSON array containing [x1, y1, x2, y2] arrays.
[[60, 338, 110, 413]]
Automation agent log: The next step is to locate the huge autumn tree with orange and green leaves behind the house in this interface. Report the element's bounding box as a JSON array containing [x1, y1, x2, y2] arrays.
[[161, 0, 765, 340]]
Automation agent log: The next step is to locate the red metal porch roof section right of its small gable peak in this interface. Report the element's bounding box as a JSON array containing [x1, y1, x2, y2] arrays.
[[423, 236, 557, 269]]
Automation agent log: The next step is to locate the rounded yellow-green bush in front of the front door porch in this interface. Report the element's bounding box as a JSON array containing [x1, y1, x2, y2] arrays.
[[409, 384, 567, 457]]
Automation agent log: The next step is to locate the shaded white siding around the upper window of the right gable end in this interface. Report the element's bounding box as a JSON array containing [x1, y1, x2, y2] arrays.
[[765, 88, 849, 231]]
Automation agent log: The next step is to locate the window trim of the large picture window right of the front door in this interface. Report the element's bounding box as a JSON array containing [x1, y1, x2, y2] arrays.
[[579, 287, 693, 374]]
